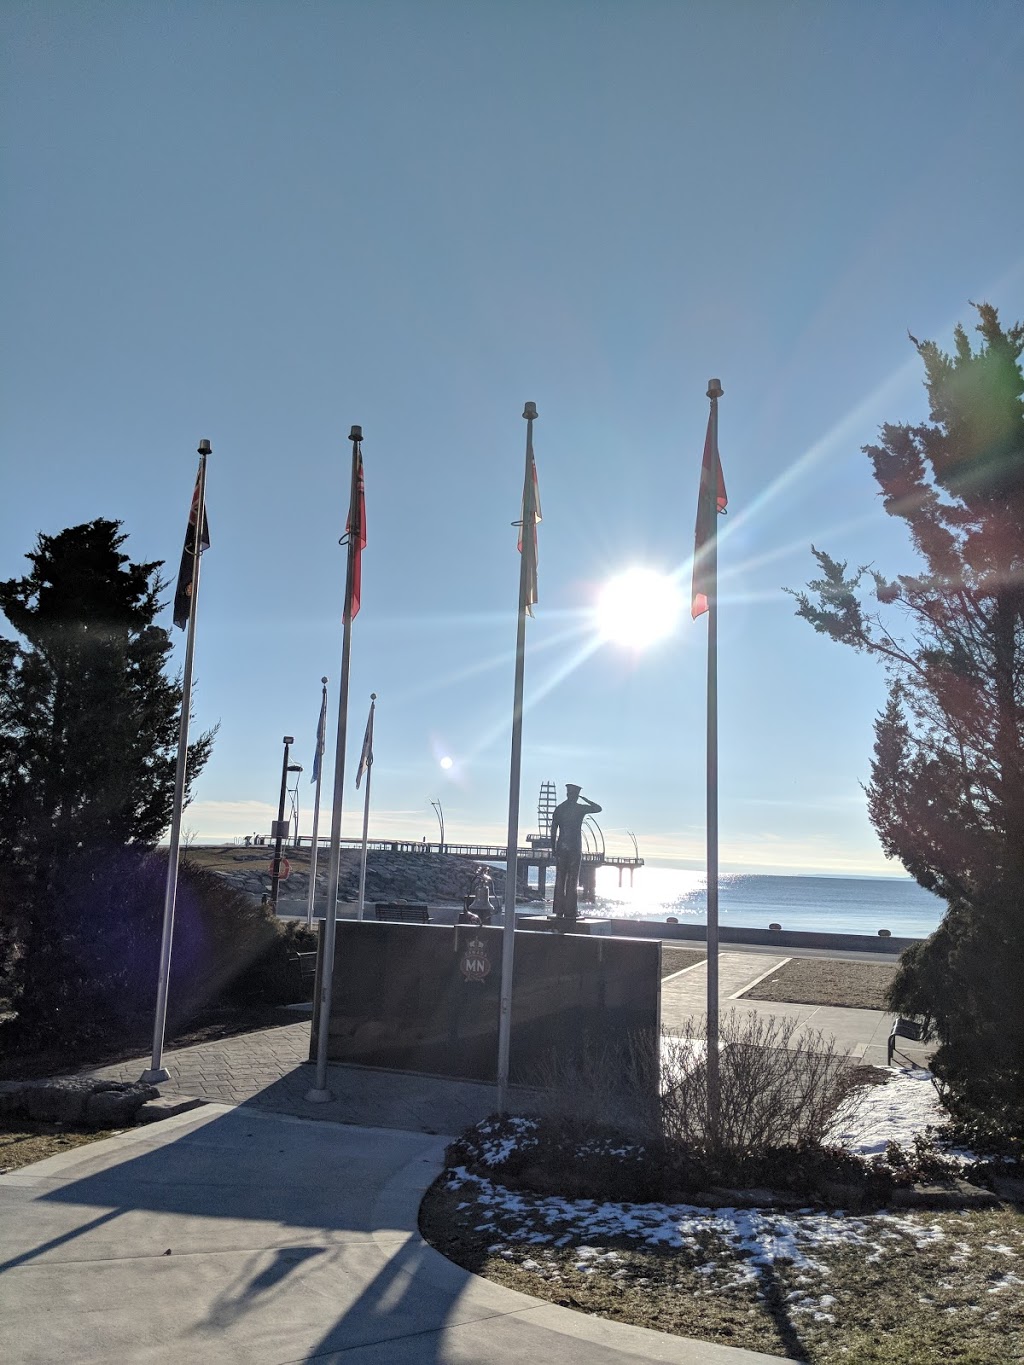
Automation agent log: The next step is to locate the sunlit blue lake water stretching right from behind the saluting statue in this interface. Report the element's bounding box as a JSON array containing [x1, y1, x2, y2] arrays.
[[580, 867, 945, 938]]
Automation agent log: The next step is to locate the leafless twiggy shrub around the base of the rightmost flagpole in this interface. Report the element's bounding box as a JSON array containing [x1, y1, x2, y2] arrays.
[[661, 1010, 856, 1159]]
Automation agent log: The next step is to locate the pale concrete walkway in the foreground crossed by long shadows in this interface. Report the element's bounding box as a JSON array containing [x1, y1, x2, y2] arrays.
[[0, 1102, 777, 1365]]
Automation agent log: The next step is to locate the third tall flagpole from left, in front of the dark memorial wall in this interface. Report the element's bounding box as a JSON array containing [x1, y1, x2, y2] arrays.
[[498, 403, 537, 1114]]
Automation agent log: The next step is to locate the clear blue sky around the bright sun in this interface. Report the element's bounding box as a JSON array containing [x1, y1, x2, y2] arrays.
[[0, 0, 1024, 874]]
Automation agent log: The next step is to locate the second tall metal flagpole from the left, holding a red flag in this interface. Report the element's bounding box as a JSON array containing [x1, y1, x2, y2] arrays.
[[306, 426, 363, 1104]]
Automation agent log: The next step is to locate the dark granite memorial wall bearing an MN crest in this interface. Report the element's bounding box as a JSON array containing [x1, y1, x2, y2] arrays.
[[310, 920, 661, 1085]]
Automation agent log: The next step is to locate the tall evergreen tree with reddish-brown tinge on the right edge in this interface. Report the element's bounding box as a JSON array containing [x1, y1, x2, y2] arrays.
[[795, 304, 1024, 1122]]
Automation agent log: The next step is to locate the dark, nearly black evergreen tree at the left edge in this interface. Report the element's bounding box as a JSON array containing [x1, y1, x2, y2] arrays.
[[0, 519, 213, 1021]]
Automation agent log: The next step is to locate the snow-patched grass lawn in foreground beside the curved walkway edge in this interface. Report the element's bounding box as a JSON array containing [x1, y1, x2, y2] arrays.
[[421, 1177, 1024, 1365]]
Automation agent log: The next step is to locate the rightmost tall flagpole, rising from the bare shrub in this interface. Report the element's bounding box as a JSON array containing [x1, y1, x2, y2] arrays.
[[700, 379, 724, 1144]]
